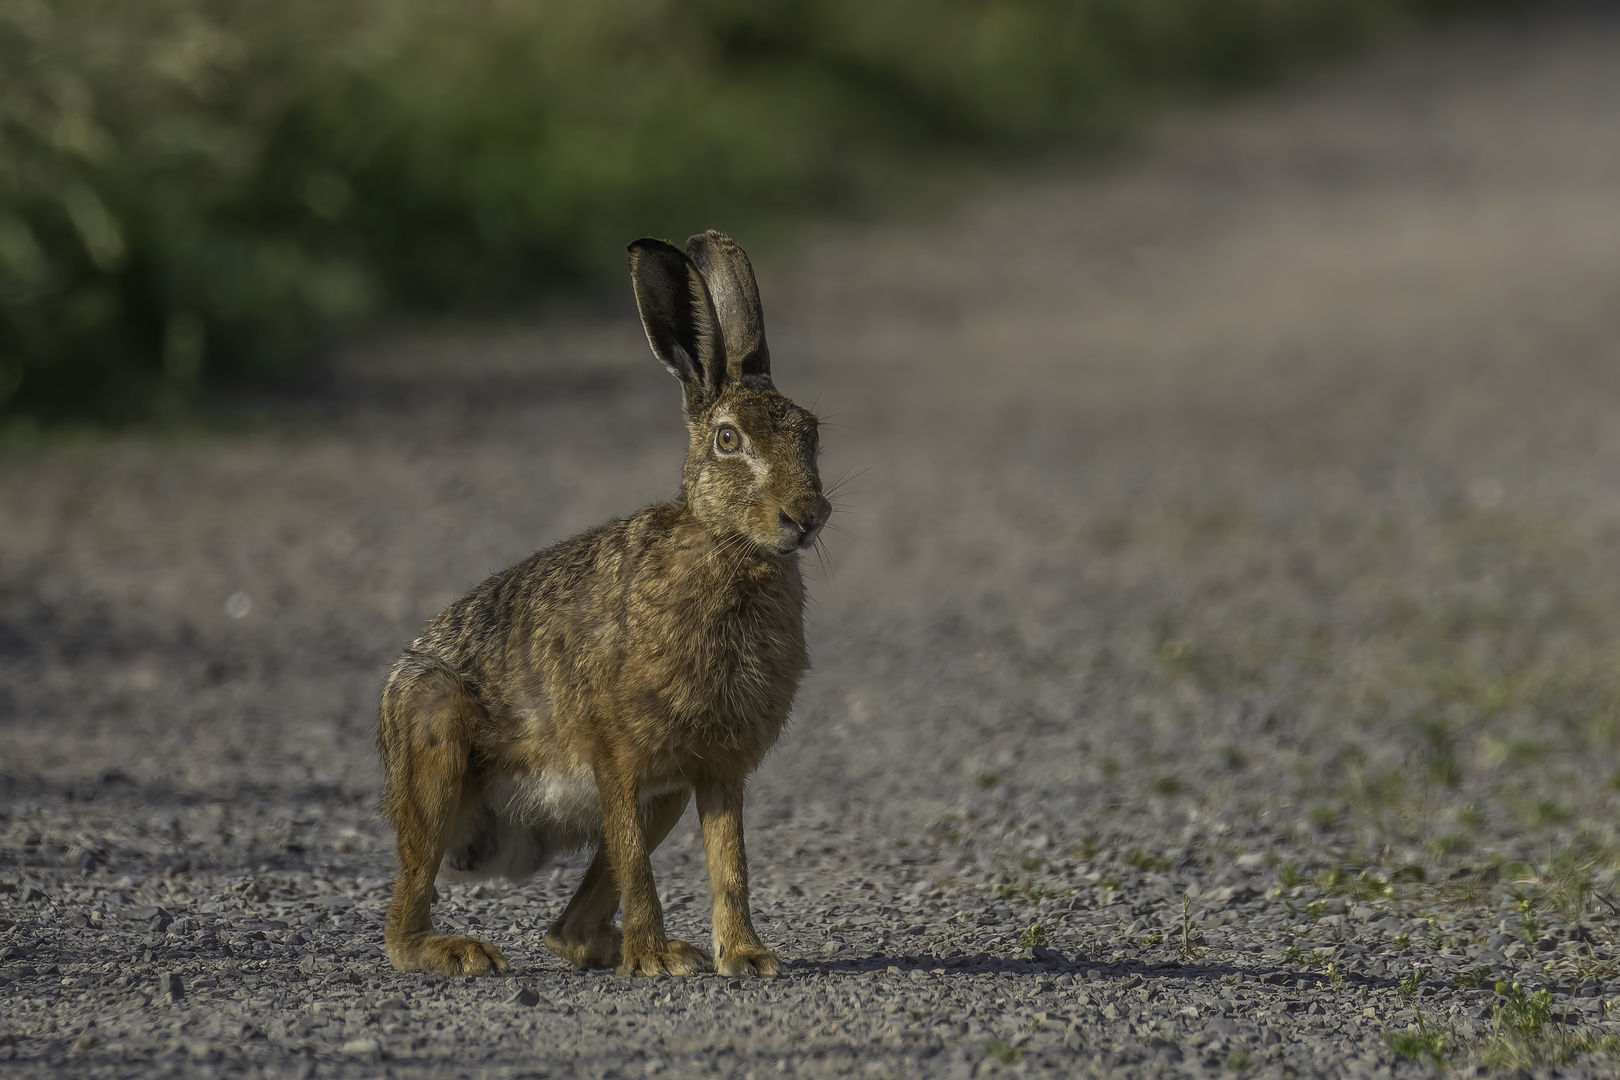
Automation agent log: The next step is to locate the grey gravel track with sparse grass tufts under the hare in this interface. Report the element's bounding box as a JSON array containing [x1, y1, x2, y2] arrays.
[[0, 16, 1620, 1077]]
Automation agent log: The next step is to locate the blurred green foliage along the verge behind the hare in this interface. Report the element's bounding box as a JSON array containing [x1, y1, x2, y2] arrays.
[[0, 0, 1503, 421]]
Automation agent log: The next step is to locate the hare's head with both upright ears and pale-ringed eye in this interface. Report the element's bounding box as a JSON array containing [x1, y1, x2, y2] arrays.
[[630, 230, 833, 555]]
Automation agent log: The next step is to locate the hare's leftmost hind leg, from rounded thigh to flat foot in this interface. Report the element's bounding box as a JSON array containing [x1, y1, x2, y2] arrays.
[[377, 664, 507, 975]]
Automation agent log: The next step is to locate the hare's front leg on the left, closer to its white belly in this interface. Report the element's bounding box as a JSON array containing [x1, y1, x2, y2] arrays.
[[596, 761, 714, 975]]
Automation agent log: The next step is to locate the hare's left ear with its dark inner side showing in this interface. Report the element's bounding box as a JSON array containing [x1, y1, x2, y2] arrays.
[[629, 238, 726, 410]]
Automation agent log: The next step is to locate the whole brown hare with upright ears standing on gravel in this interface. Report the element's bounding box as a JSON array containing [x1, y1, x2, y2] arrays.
[[377, 232, 831, 976]]
